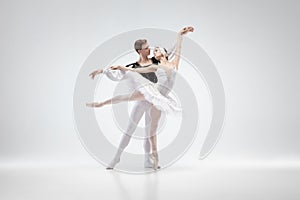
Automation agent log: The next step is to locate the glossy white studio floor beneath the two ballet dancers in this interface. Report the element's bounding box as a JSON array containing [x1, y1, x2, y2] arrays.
[[0, 161, 300, 200]]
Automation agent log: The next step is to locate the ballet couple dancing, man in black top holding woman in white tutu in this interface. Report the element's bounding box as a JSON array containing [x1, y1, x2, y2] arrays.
[[86, 27, 194, 170]]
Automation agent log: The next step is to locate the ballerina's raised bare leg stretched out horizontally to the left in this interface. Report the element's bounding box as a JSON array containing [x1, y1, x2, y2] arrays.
[[86, 91, 145, 107]]
